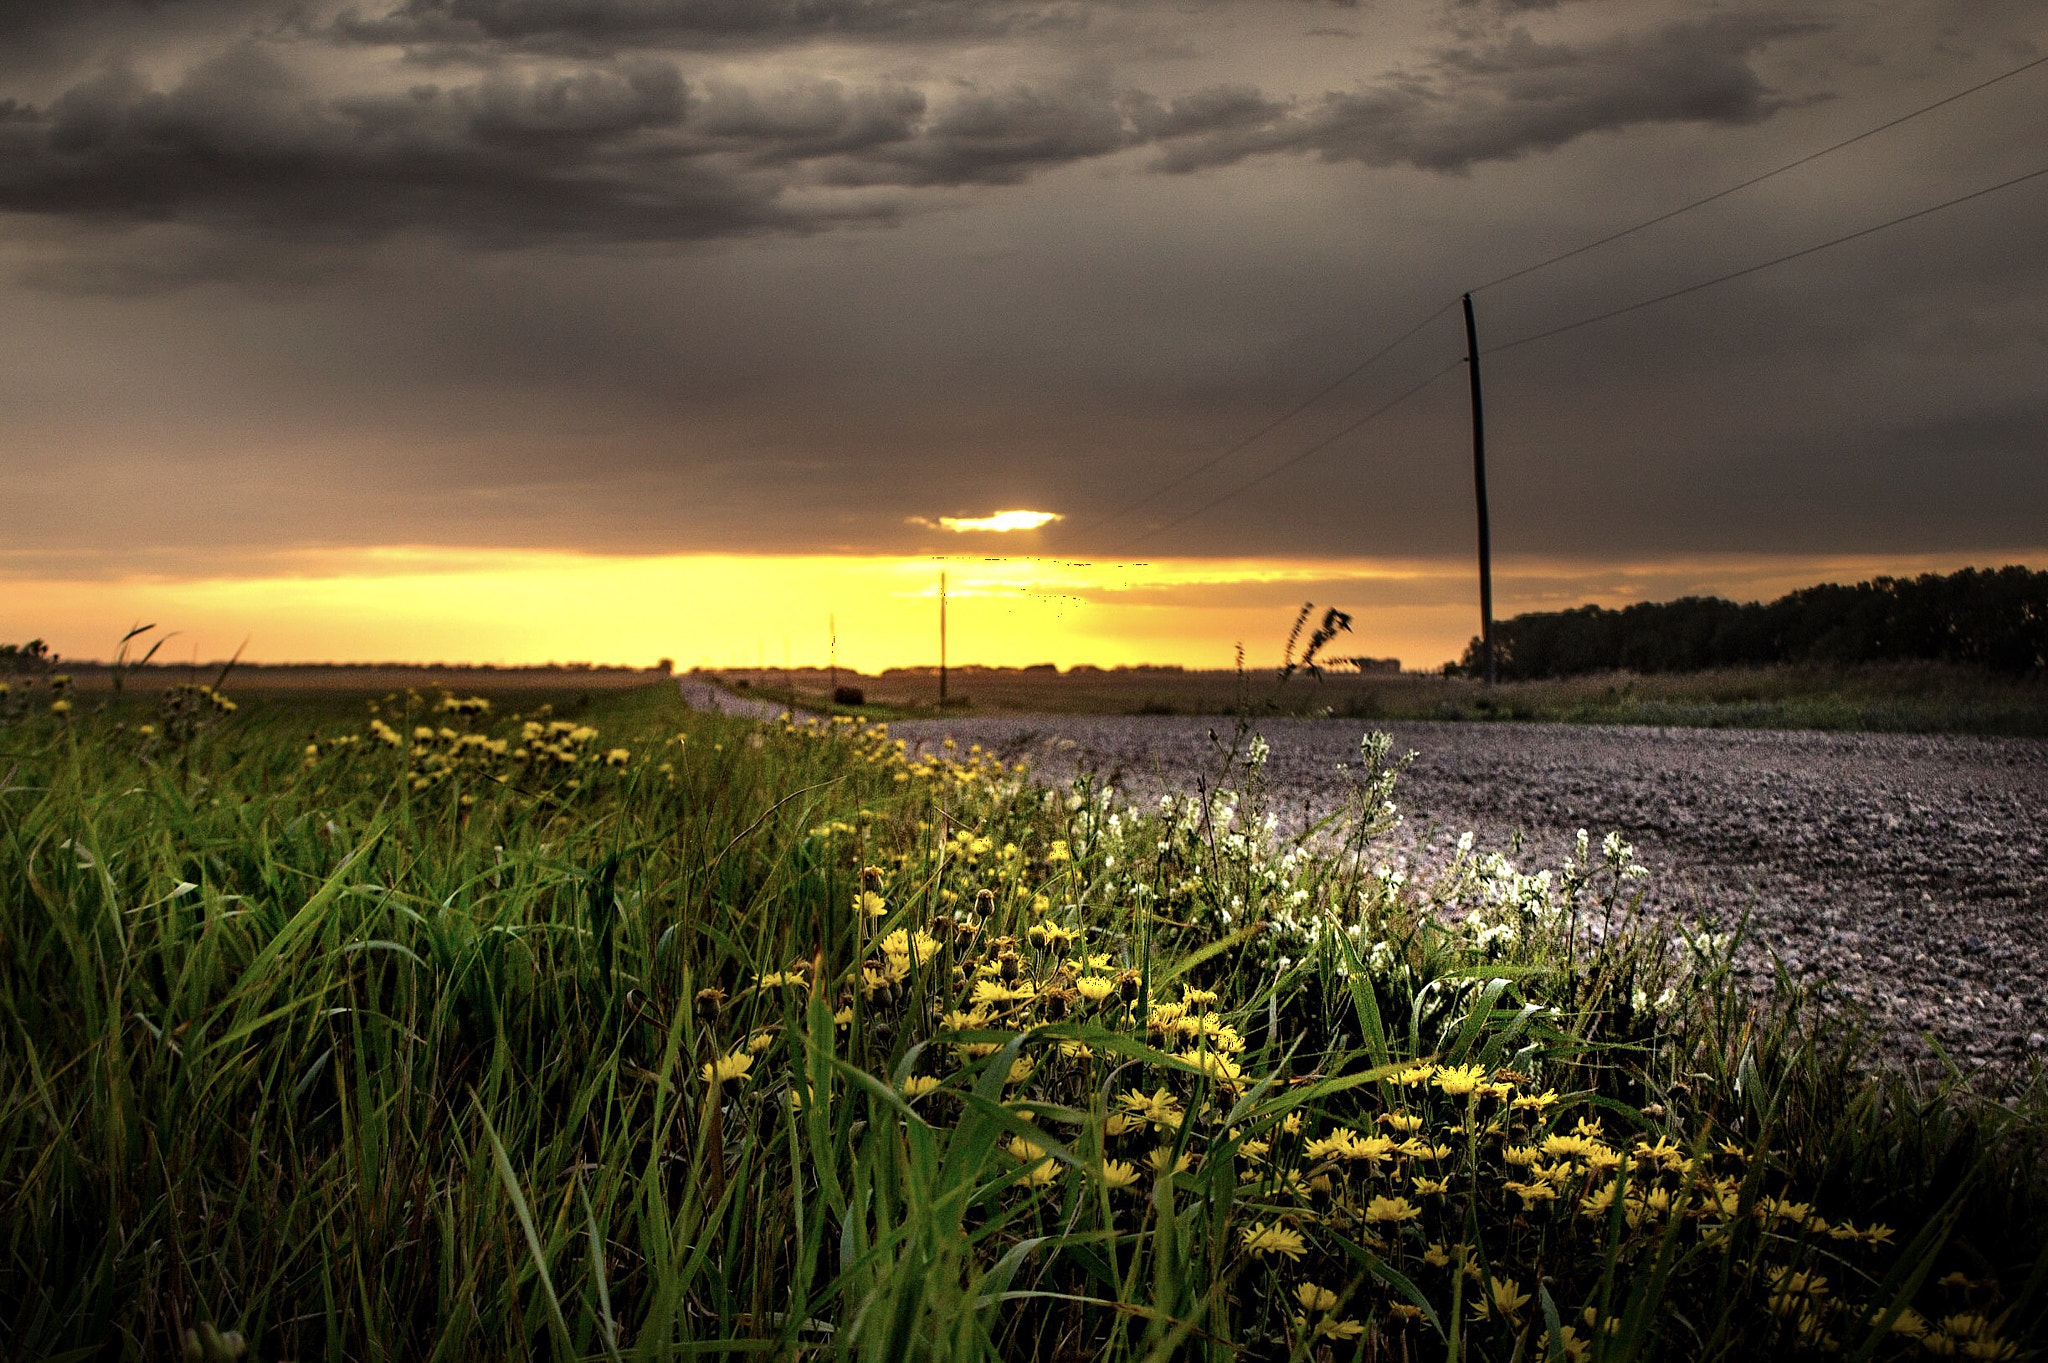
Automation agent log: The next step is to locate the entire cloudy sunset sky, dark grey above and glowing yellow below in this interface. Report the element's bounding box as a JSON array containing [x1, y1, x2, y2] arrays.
[[0, 0, 2048, 669]]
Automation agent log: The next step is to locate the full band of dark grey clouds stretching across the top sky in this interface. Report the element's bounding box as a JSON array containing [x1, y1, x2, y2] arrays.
[[0, 0, 1812, 266]]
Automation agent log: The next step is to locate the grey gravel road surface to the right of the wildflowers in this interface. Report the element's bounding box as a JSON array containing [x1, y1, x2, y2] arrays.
[[891, 716, 2048, 1068]]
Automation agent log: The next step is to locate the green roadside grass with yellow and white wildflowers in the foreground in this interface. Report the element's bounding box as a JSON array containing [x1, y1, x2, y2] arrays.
[[0, 686, 2048, 1363]]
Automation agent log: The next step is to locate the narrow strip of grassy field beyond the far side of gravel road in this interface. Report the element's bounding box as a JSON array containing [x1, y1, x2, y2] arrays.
[[715, 663, 2048, 737]]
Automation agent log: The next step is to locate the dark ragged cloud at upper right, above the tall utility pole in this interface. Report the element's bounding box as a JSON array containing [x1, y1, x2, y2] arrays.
[[1161, 16, 1821, 172]]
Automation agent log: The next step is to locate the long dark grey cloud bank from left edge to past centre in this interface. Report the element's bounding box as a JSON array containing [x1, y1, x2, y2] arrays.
[[0, 43, 1171, 246]]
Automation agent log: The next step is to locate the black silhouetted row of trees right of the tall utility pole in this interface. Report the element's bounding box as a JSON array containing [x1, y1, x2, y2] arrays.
[[1456, 565, 2048, 682]]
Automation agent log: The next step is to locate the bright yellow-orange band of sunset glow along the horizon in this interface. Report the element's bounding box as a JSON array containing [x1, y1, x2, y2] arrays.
[[0, 546, 2048, 673]]
